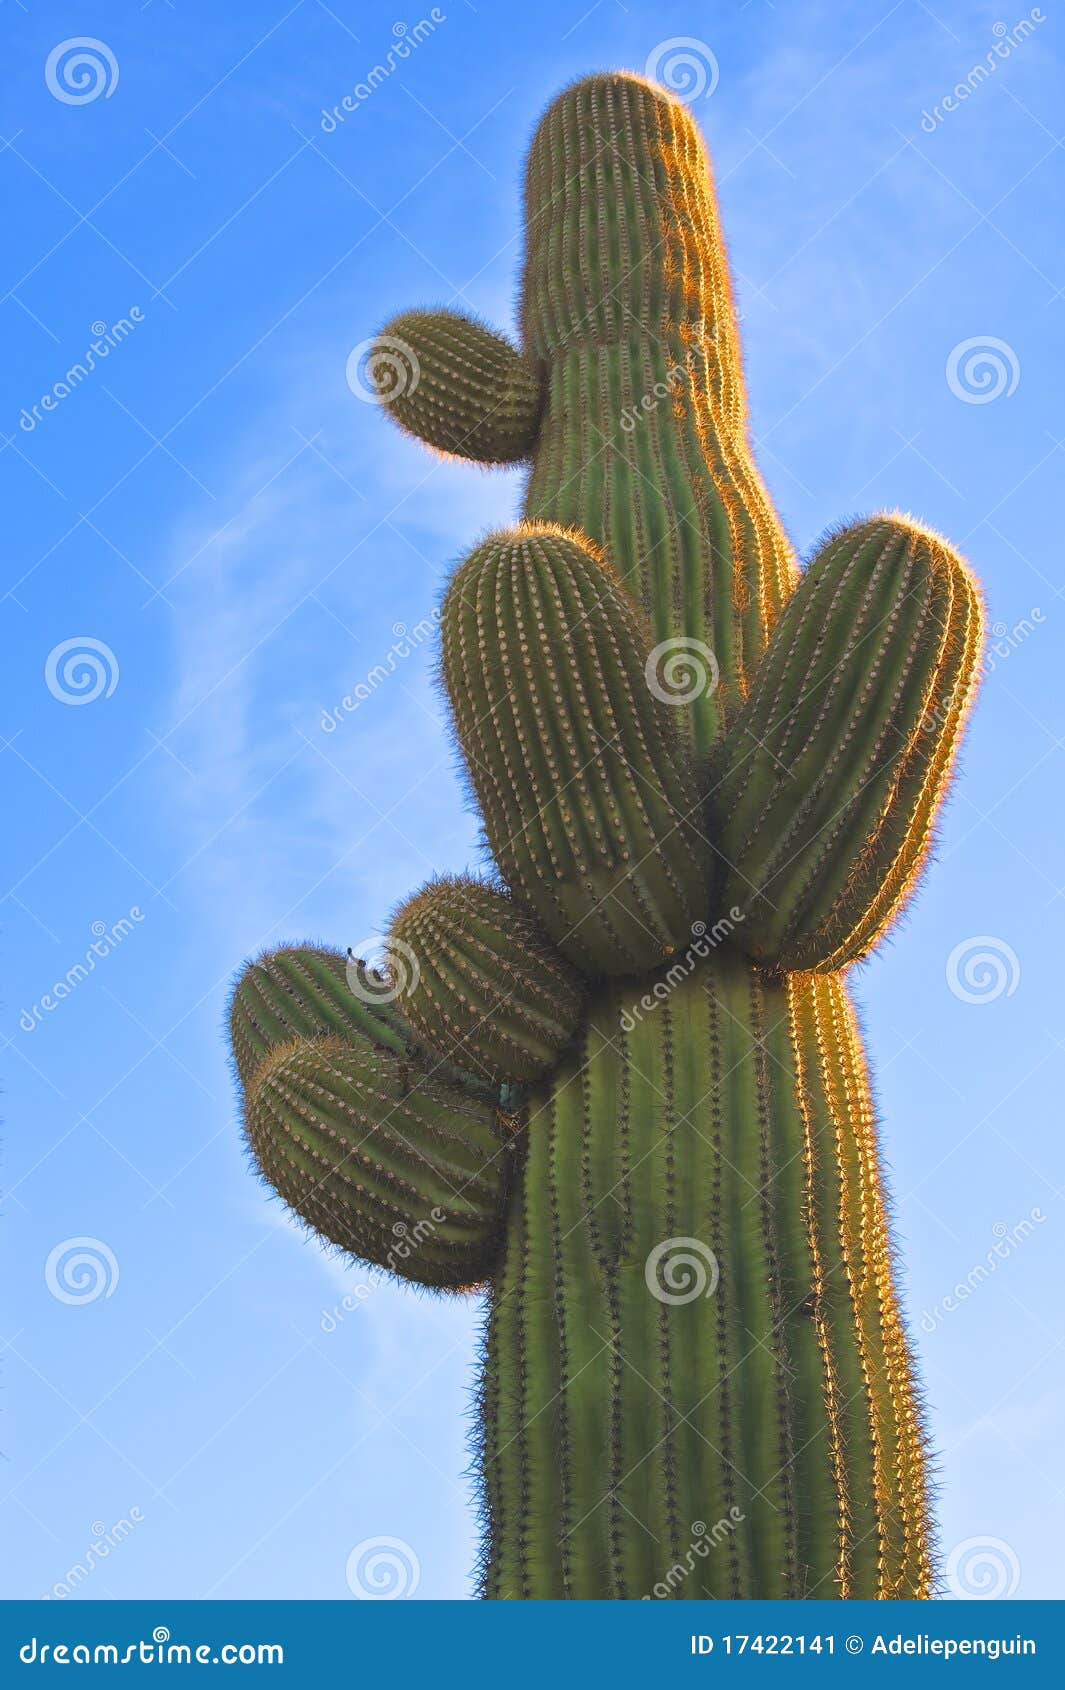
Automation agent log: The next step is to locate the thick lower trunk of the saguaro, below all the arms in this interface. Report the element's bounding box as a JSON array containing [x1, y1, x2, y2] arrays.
[[482, 950, 931, 1599]]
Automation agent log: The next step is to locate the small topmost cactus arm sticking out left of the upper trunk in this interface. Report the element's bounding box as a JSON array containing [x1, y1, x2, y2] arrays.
[[370, 311, 543, 463]]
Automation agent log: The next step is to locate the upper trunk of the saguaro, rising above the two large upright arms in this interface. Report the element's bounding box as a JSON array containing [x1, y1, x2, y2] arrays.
[[524, 76, 796, 755]]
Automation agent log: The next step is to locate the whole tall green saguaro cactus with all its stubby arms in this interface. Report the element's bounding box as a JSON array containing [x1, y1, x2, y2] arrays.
[[232, 74, 980, 1597]]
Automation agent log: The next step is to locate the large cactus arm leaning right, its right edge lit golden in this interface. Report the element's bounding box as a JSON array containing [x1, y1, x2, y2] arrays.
[[708, 517, 982, 972]]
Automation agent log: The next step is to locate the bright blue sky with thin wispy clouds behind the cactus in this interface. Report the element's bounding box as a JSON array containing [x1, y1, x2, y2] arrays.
[[0, 0, 1065, 1599]]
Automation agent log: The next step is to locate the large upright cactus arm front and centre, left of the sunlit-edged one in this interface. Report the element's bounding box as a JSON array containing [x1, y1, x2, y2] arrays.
[[443, 526, 707, 973]]
